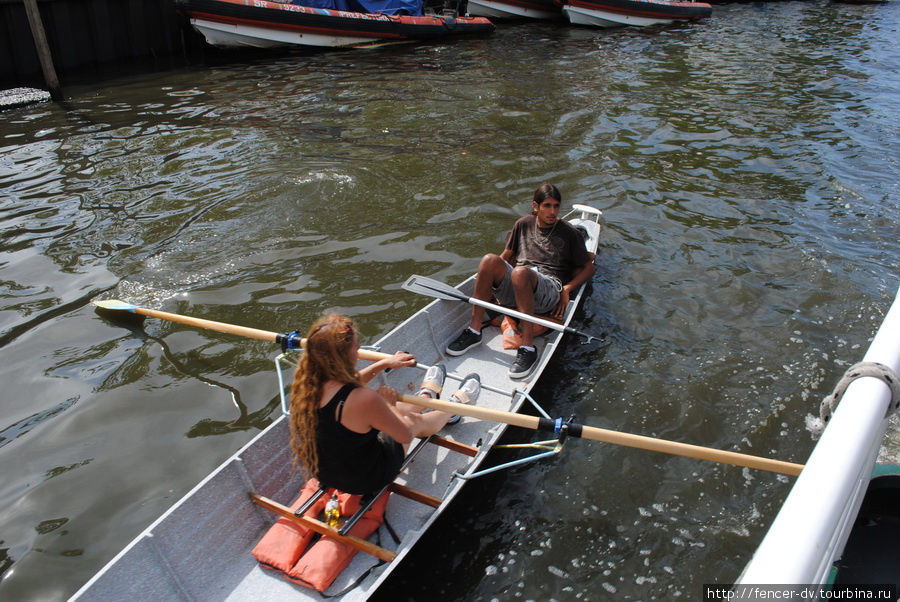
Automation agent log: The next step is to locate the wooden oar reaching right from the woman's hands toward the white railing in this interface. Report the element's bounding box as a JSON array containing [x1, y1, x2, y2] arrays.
[[401, 395, 803, 476]]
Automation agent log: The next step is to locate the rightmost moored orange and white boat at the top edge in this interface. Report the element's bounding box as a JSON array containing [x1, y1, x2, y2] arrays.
[[561, 0, 712, 27]]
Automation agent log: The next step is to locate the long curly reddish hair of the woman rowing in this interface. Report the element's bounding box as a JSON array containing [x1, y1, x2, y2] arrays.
[[290, 314, 362, 476]]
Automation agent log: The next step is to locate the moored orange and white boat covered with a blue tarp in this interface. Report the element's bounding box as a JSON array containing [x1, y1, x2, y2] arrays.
[[176, 0, 494, 48]]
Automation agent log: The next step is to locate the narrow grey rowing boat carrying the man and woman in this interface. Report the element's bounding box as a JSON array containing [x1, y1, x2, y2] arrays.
[[73, 205, 601, 600]]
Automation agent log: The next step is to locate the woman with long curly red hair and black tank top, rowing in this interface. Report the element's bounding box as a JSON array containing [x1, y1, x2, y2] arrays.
[[290, 314, 480, 494]]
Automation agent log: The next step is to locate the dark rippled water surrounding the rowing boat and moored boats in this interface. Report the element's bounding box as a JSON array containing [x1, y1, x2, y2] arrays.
[[0, 1, 900, 600]]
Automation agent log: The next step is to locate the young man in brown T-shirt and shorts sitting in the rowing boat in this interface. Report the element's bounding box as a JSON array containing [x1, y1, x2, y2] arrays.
[[447, 183, 594, 378]]
